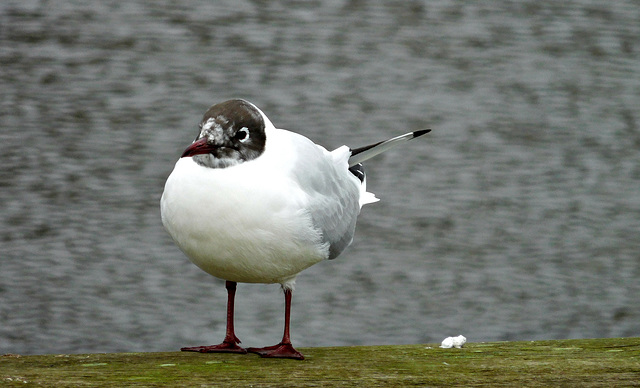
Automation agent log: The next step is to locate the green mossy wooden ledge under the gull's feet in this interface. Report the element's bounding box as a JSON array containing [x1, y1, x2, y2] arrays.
[[0, 338, 640, 387]]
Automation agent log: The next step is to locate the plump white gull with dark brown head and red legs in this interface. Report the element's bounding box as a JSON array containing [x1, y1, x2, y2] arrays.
[[160, 99, 431, 360]]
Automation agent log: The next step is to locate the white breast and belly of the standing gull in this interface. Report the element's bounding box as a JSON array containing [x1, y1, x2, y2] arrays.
[[161, 158, 328, 283]]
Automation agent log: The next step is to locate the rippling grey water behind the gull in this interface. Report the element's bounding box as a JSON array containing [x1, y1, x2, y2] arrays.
[[0, 0, 640, 354]]
